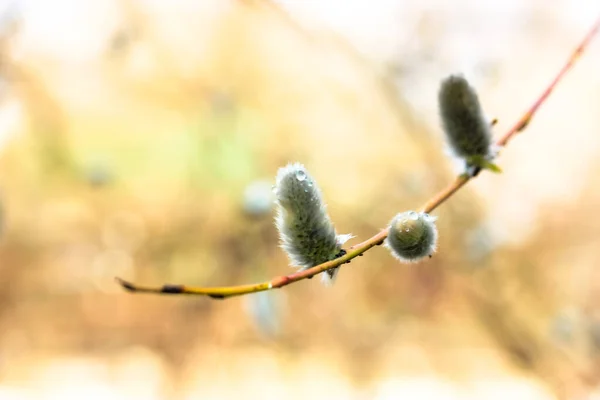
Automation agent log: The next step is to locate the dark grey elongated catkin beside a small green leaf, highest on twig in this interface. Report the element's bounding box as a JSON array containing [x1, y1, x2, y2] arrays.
[[438, 75, 493, 159]]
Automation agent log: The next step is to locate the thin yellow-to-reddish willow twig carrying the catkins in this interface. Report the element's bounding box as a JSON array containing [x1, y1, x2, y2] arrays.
[[115, 14, 600, 299]]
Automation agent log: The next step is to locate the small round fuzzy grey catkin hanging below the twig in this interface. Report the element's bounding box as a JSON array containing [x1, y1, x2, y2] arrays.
[[385, 211, 438, 263]]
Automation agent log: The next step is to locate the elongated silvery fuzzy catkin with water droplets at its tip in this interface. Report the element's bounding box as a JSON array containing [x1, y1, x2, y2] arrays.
[[274, 163, 351, 284]]
